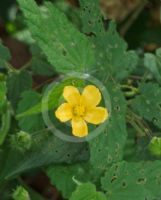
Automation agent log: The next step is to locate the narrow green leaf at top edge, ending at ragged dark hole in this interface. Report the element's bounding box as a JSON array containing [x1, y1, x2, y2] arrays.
[[79, 0, 104, 35]]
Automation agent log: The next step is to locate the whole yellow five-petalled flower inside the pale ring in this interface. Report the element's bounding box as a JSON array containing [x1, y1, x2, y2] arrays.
[[55, 85, 108, 137]]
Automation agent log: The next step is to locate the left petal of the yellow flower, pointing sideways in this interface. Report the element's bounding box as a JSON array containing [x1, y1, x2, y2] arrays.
[[55, 103, 72, 122]]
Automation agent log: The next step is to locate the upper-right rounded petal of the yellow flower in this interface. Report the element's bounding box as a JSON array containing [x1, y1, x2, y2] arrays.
[[82, 85, 101, 107]]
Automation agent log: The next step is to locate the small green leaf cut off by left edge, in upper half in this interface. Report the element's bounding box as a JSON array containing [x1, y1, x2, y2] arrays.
[[0, 42, 11, 68]]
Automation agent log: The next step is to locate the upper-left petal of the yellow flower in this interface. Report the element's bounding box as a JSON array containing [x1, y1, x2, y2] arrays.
[[63, 86, 80, 105]]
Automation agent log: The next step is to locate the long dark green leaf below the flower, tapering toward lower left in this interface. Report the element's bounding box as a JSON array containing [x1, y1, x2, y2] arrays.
[[0, 130, 89, 182]]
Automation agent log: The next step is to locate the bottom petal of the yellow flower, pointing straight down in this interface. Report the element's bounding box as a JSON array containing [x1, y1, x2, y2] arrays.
[[72, 117, 88, 137]]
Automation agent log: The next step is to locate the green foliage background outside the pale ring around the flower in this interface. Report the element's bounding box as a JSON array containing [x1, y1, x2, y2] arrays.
[[0, 0, 161, 200]]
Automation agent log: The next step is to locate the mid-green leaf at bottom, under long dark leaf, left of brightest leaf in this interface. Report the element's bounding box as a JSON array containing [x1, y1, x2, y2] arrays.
[[46, 163, 90, 199]]
